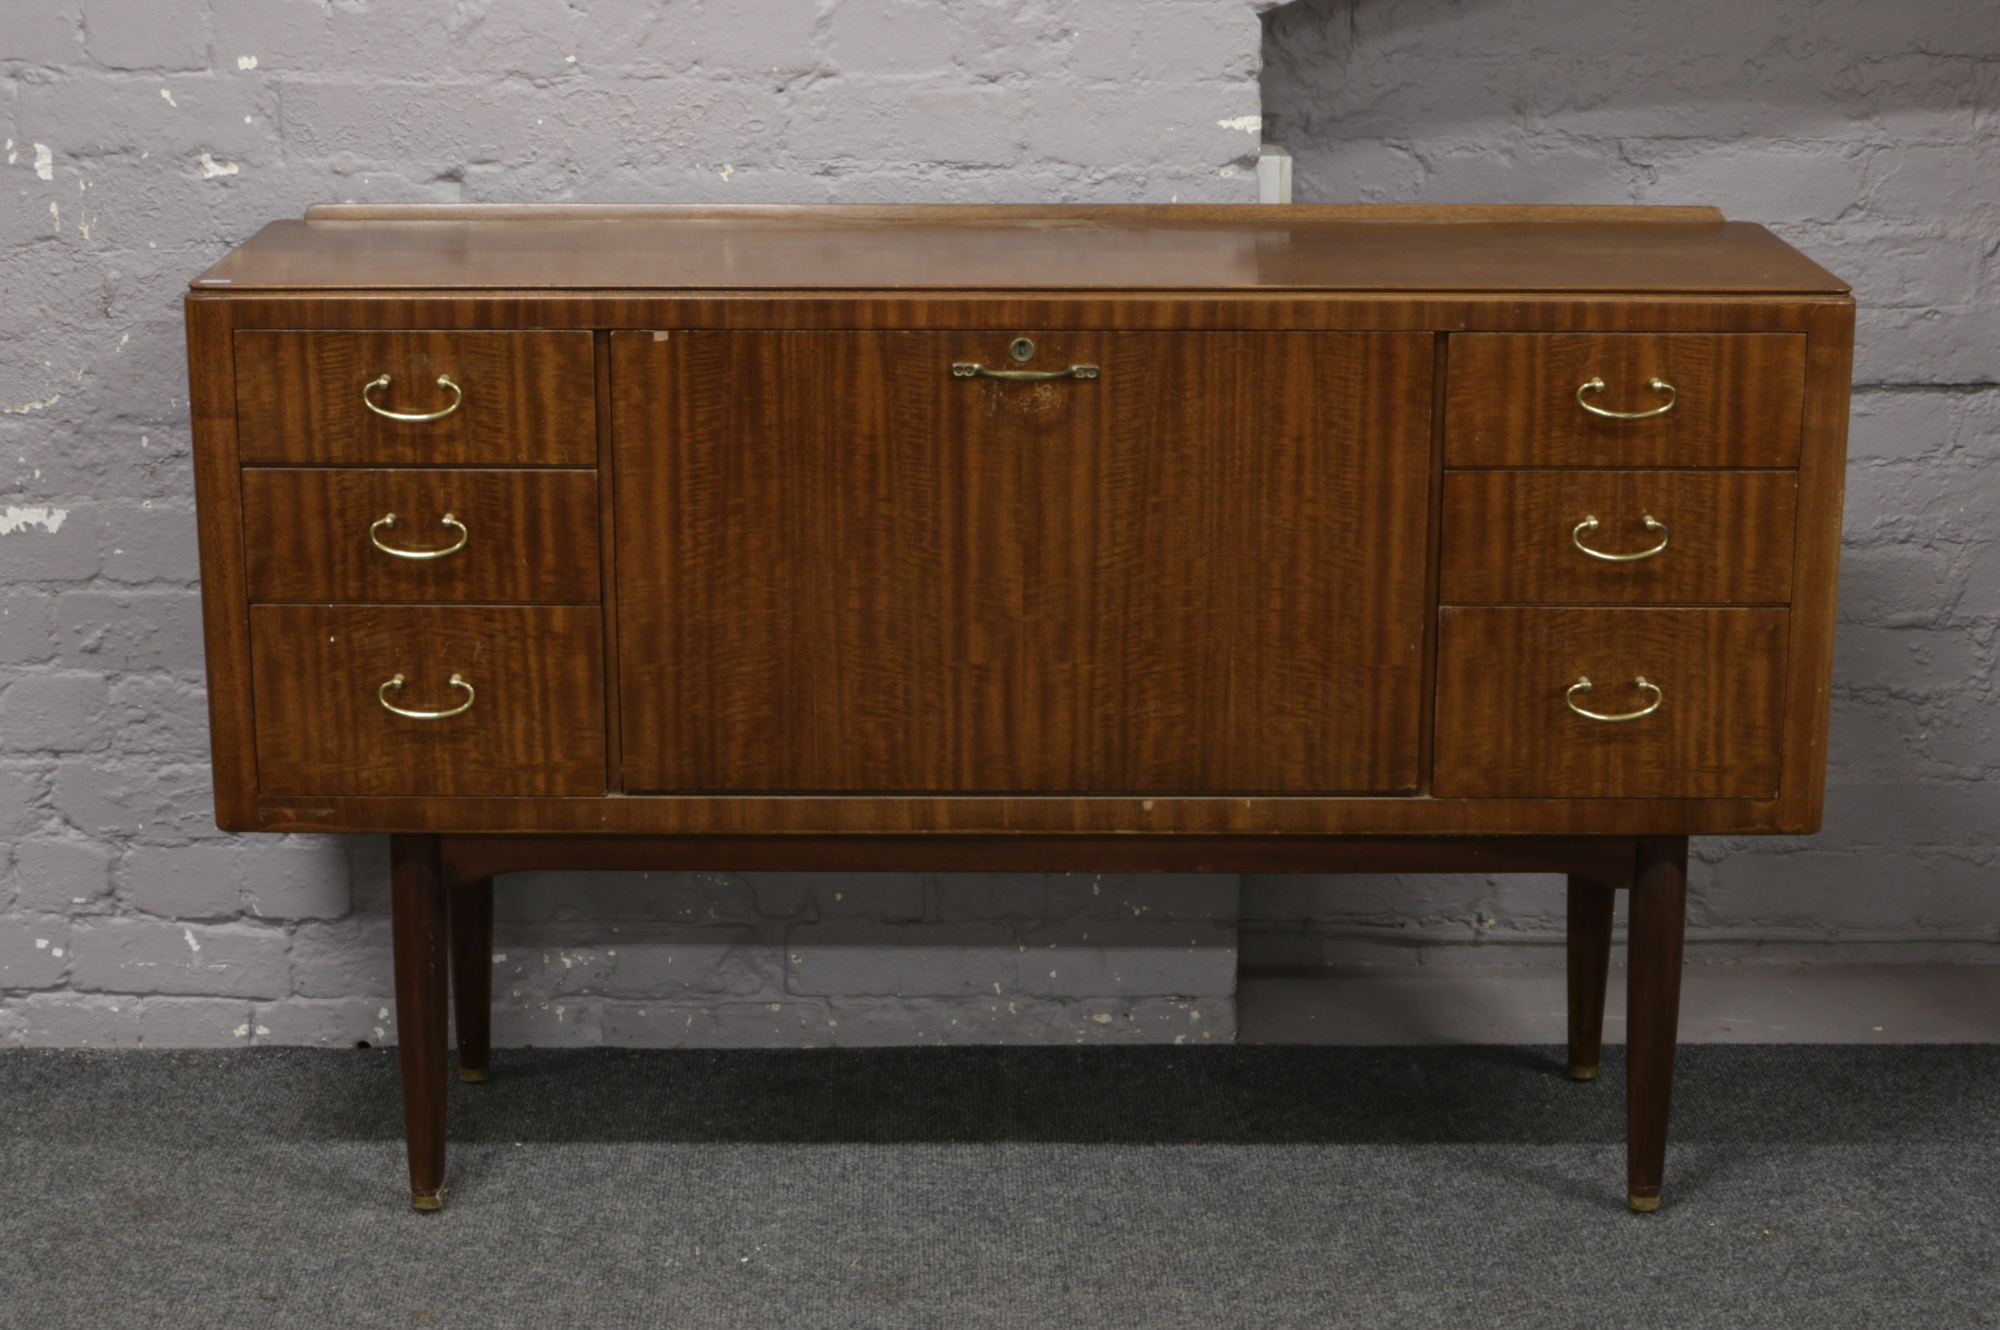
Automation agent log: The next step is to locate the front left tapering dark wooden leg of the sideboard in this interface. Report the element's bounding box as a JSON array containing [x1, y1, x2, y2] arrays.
[[388, 836, 448, 1210]]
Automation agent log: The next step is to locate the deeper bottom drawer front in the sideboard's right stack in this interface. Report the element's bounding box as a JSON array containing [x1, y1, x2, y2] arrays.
[[1434, 608, 1790, 798]]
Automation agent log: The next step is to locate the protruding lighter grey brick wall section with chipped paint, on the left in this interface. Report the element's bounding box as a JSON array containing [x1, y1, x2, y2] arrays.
[[0, 0, 1268, 1046]]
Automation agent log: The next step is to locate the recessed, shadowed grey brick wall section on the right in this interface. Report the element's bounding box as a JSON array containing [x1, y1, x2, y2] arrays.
[[1242, 0, 2000, 962]]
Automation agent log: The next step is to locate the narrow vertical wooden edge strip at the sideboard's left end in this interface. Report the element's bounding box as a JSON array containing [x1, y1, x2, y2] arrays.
[[184, 296, 258, 832]]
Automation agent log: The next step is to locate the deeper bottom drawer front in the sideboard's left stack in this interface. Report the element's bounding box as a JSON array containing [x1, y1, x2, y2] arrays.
[[250, 606, 604, 794]]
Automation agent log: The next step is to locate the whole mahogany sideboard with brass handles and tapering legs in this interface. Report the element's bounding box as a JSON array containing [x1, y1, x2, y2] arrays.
[[186, 206, 1854, 1210]]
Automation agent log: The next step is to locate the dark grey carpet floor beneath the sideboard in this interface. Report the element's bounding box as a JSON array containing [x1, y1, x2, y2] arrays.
[[0, 1044, 2000, 1330]]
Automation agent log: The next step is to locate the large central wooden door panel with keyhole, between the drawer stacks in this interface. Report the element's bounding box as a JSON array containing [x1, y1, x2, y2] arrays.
[[612, 332, 1432, 794]]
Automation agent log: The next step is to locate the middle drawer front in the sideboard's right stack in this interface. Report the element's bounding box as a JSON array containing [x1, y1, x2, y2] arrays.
[[1438, 470, 1798, 604]]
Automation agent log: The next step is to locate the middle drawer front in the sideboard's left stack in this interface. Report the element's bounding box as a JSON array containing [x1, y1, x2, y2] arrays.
[[244, 468, 602, 604]]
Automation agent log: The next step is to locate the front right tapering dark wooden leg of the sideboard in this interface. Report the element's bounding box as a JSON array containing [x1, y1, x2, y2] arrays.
[[1626, 836, 1688, 1210]]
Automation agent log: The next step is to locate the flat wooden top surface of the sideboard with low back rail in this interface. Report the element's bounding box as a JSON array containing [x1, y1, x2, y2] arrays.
[[192, 204, 1848, 298]]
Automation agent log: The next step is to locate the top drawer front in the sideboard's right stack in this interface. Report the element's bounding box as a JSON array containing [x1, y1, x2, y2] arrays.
[[1444, 332, 1806, 466]]
